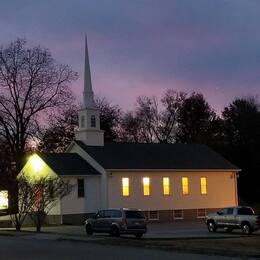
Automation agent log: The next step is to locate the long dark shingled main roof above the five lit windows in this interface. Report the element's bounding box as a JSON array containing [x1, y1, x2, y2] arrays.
[[75, 141, 239, 170]]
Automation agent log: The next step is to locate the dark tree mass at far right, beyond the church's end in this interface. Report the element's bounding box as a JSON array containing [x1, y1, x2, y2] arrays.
[[219, 98, 260, 203]]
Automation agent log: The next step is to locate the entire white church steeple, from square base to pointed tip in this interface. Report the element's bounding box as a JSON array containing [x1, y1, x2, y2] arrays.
[[76, 37, 104, 146]]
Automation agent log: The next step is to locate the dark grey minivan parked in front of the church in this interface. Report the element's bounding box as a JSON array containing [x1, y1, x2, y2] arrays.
[[85, 208, 147, 238]]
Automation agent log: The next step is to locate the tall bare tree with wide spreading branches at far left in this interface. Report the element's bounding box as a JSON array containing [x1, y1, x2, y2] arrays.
[[0, 39, 77, 174]]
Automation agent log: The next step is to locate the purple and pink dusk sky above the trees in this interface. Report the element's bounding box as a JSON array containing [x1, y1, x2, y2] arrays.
[[0, 0, 260, 111]]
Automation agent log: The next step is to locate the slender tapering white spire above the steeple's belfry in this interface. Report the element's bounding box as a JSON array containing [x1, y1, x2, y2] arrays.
[[83, 36, 96, 108]]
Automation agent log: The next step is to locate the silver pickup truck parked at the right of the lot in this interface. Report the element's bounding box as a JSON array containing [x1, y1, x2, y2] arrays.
[[206, 207, 260, 234]]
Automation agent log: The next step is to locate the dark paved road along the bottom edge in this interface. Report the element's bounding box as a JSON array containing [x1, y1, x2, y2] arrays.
[[0, 236, 237, 260]]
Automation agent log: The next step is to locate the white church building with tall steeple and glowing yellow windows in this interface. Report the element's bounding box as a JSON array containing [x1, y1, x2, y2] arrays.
[[19, 38, 239, 224]]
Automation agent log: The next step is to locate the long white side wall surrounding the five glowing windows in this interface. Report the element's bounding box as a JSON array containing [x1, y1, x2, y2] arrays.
[[108, 172, 237, 210]]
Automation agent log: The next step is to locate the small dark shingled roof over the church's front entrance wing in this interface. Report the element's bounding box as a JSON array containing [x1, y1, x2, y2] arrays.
[[38, 153, 100, 176]]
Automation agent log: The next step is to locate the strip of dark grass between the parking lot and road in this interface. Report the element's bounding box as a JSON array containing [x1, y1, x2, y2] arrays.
[[90, 235, 260, 258]]
